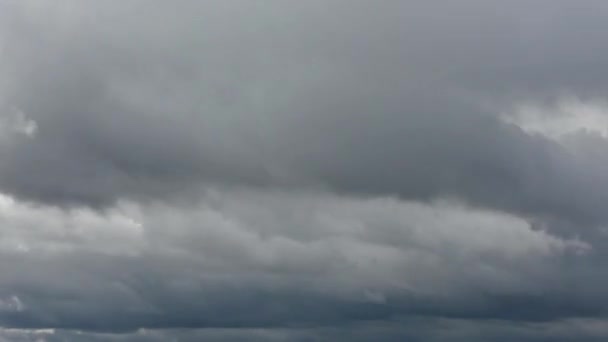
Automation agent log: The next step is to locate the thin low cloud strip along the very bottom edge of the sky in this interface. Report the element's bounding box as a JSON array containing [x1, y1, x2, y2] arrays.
[[5, 317, 606, 342]]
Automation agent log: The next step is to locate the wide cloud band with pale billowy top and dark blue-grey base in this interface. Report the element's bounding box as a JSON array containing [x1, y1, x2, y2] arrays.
[[0, 190, 592, 331]]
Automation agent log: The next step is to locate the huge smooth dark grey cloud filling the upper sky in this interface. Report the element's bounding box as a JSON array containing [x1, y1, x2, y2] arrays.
[[0, 1, 608, 223]]
